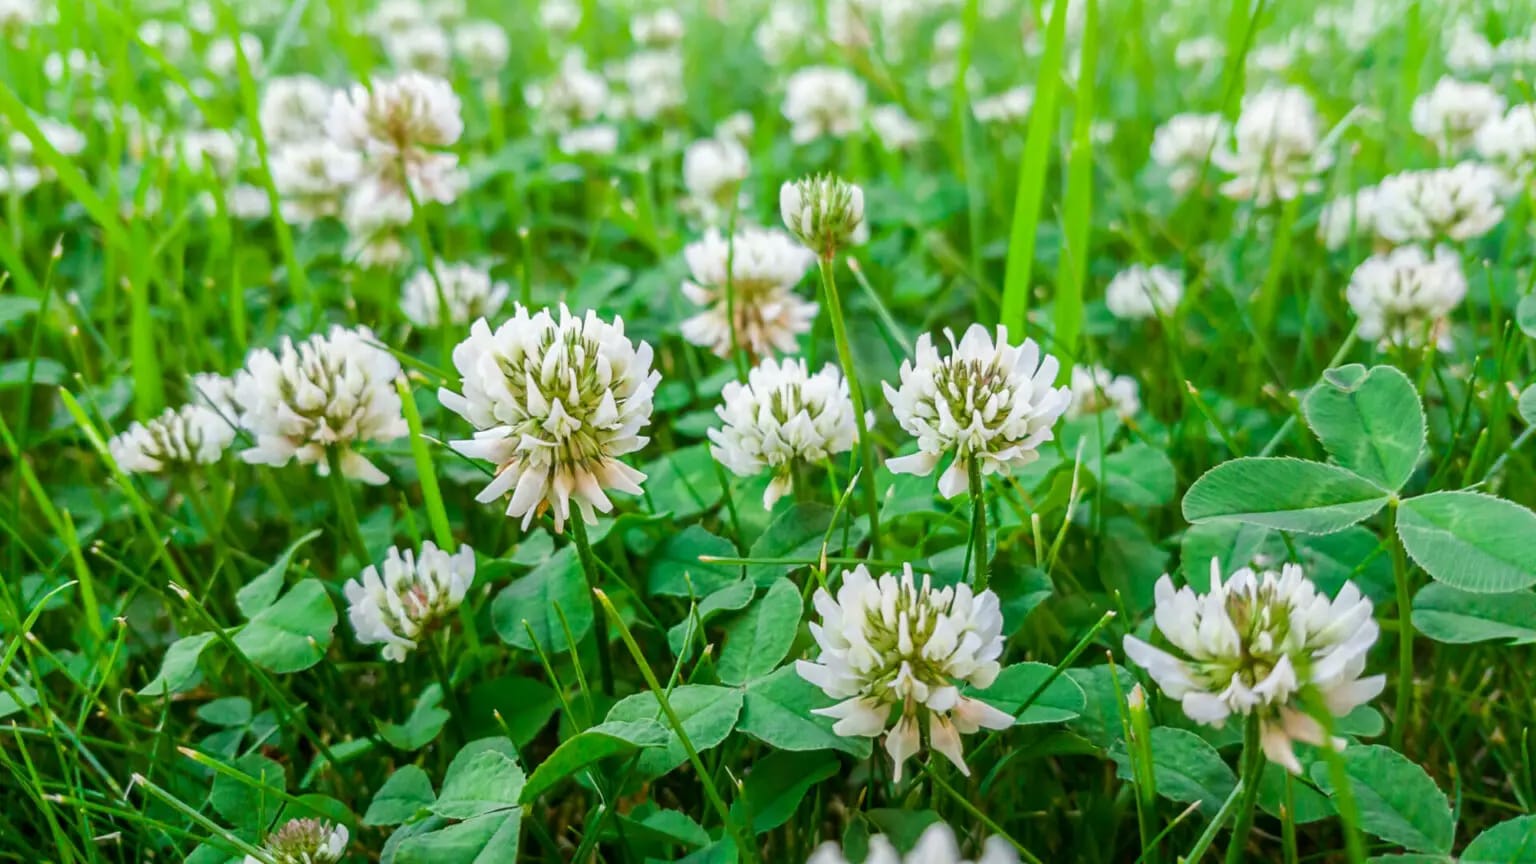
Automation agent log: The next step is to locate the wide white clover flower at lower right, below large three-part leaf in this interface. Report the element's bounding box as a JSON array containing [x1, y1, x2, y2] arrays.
[[1124, 560, 1385, 773]]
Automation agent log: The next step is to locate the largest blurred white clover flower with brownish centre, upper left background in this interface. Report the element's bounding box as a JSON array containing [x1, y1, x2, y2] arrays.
[[326, 72, 467, 204]]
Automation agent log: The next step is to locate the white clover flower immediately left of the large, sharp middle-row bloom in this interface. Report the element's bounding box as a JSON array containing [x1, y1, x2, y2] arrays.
[[235, 326, 407, 484]]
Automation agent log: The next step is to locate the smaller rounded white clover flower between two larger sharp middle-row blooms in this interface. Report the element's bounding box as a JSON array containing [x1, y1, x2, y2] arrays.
[[710, 358, 857, 510]]
